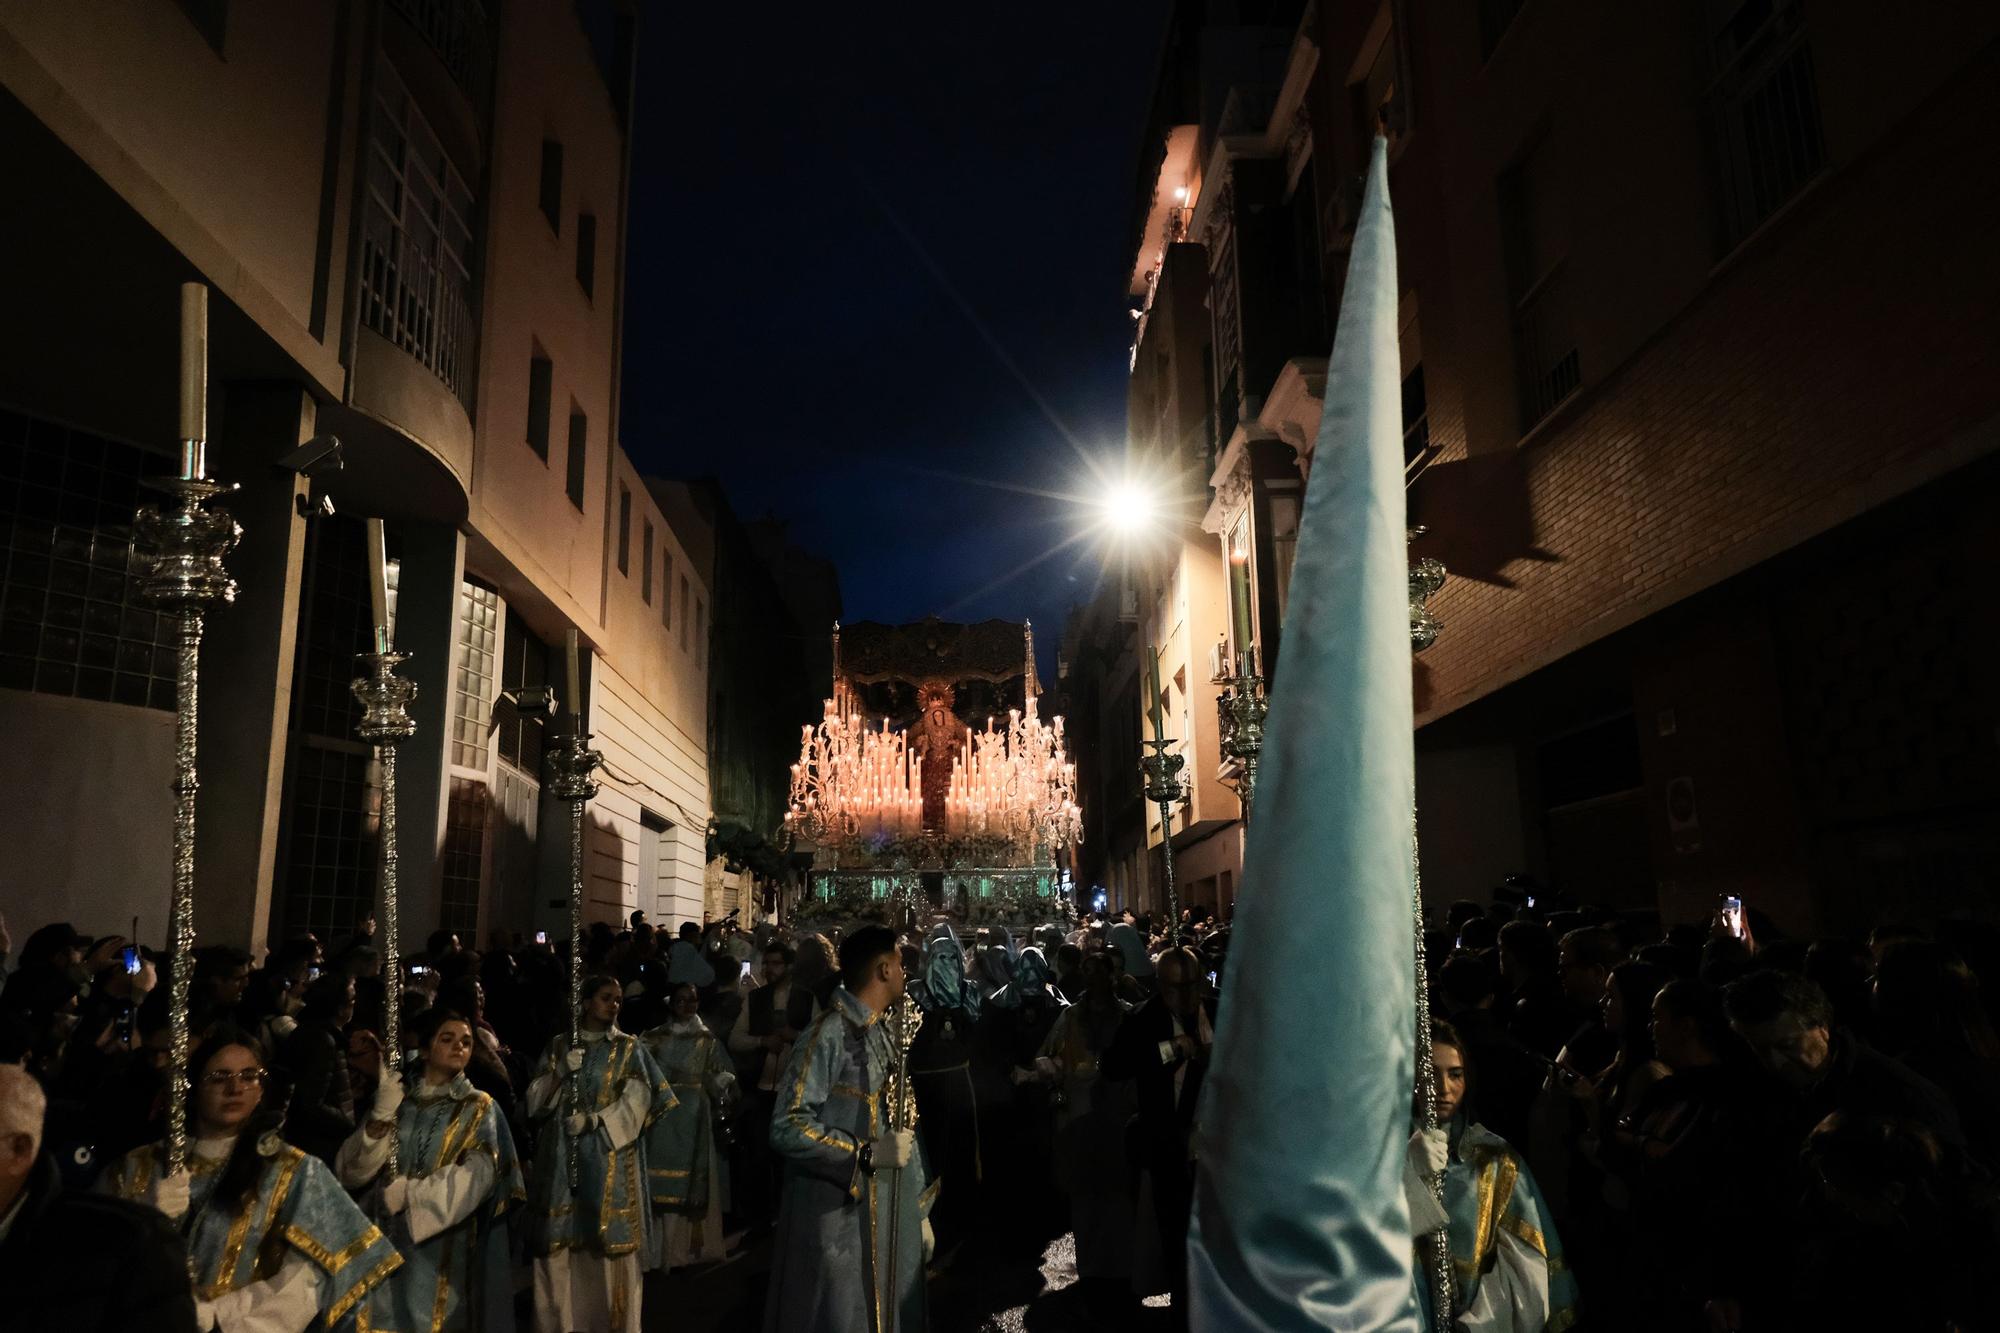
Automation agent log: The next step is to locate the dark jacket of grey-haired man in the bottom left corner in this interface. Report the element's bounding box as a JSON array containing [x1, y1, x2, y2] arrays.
[[0, 1153, 194, 1333]]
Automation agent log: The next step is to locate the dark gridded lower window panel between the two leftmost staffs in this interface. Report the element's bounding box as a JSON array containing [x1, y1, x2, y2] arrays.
[[284, 743, 376, 939]]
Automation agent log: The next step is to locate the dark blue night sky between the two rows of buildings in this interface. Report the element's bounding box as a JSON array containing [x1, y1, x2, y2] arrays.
[[622, 2, 1166, 648]]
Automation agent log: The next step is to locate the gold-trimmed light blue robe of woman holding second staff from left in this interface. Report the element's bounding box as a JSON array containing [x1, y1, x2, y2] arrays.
[[360, 1075, 528, 1333]]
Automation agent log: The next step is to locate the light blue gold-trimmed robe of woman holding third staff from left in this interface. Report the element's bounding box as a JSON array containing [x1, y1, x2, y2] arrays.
[[528, 1031, 674, 1259]]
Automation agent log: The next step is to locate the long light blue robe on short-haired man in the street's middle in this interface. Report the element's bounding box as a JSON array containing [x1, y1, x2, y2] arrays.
[[764, 987, 936, 1333]]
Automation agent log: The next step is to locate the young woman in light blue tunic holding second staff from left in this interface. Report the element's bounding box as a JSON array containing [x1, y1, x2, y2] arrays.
[[334, 1009, 526, 1333]]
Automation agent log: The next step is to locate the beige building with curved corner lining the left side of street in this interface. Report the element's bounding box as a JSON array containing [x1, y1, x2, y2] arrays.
[[0, 0, 710, 947]]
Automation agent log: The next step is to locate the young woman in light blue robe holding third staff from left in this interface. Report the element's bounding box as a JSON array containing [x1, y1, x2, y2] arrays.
[[528, 977, 674, 1333]]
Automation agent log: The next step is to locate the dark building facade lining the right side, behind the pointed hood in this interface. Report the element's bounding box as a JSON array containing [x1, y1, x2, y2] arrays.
[[1098, 0, 2000, 931]]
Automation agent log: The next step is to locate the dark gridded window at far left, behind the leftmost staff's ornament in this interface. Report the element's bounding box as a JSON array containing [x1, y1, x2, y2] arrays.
[[0, 410, 176, 709]]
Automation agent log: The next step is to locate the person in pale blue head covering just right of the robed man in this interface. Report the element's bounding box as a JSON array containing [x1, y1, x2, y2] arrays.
[[908, 923, 984, 1255]]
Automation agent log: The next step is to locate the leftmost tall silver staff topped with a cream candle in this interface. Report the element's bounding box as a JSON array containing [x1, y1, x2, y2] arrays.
[[132, 282, 242, 1175]]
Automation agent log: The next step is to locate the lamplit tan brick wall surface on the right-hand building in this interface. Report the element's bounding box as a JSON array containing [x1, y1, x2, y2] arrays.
[[1406, 48, 2000, 723]]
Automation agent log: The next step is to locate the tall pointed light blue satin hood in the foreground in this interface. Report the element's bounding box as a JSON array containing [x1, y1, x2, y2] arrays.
[[1188, 138, 1418, 1333]]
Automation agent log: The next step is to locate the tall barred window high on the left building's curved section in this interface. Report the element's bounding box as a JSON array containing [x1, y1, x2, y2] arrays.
[[360, 60, 478, 398]]
